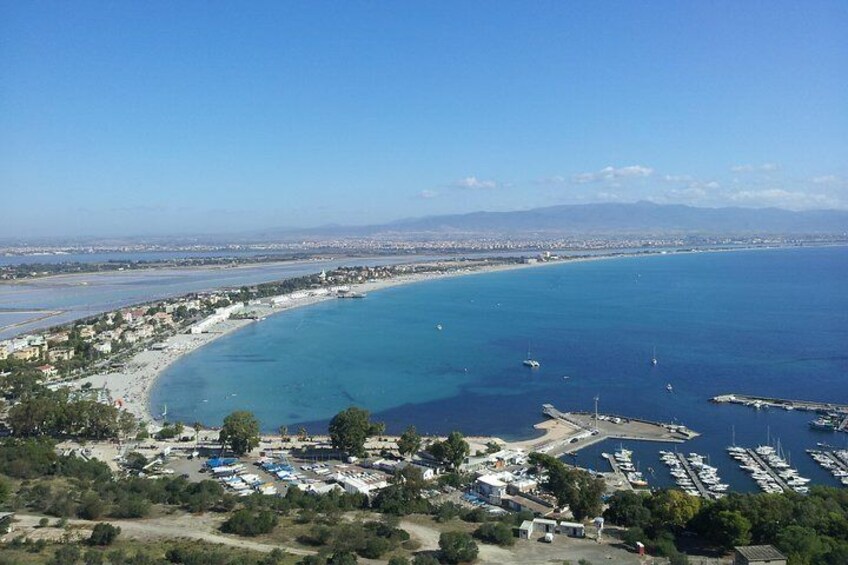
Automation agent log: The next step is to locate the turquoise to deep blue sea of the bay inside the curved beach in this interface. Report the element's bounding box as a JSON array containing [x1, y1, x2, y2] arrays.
[[152, 248, 848, 489]]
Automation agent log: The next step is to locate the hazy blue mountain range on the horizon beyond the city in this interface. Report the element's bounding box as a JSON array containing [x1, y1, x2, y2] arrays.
[[253, 202, 848, 239]]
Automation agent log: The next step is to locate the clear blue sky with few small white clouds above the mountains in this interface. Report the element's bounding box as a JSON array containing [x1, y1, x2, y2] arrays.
[[0, 1, 848, 237]]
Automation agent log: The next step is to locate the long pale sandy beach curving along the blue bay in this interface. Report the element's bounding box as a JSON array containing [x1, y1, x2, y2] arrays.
[[73, 242, 836, 428]]
